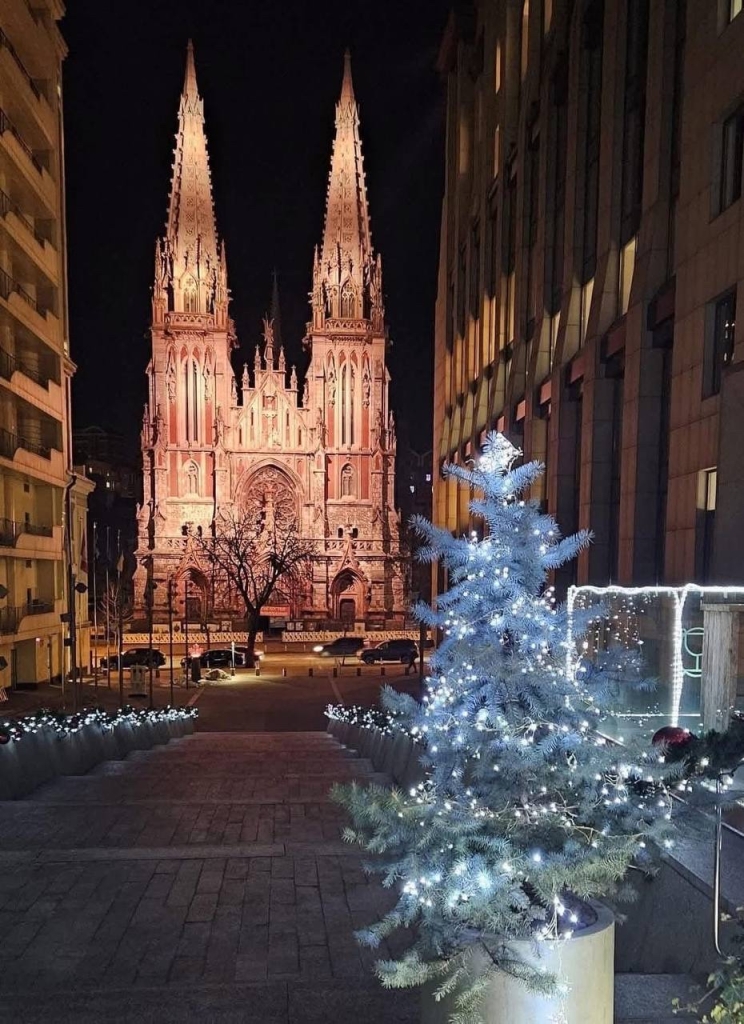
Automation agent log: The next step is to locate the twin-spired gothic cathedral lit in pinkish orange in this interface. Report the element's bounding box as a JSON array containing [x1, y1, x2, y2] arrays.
[[134, 43, 406, 625]]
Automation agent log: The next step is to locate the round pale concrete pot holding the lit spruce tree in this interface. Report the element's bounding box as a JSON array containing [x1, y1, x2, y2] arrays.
[[421, 903, 615, 1024]]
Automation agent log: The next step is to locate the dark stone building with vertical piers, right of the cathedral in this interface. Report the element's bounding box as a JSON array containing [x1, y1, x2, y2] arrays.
[[434, 0, 744, 587]]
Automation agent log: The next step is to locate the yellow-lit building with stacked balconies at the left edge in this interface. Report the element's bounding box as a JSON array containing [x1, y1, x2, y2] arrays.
[[0, 0, 88, 687]]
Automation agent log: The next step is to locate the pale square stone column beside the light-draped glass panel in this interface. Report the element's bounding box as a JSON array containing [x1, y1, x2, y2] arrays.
[[701, 603, 744, 730]]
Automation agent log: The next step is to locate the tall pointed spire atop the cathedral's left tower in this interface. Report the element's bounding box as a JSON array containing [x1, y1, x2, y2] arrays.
[[154, 40, 228, 325]]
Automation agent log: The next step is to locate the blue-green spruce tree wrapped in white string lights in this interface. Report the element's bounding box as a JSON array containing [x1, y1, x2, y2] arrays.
[[334, 434, 671, 1024]]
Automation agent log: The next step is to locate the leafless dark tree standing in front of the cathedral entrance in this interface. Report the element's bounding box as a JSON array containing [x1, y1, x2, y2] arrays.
[[196, 507, 314, 651]]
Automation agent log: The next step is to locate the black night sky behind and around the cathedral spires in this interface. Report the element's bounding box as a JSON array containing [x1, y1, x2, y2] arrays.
[[62, 0, 448, 450]]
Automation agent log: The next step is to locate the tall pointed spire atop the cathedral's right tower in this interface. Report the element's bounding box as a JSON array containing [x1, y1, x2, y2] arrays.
[[313, 50, 383, 329]]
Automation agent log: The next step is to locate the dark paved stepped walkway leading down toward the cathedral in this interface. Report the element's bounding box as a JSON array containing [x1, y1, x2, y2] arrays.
[[0, 732, 418, 1024]]
